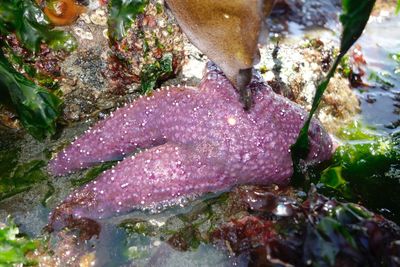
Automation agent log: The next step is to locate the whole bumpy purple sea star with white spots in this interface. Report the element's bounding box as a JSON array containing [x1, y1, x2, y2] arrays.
[[49, 63, 332, 225]]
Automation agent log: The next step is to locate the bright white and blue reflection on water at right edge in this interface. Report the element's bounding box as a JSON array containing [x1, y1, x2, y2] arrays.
[[358, 16, 400, 132]]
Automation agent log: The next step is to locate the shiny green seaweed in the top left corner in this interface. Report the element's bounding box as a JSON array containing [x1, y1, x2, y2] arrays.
[[0, 0, 77, 52]]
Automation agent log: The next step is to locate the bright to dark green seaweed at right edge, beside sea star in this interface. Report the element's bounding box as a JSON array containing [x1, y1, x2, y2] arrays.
[[318, 133, 400, 222]]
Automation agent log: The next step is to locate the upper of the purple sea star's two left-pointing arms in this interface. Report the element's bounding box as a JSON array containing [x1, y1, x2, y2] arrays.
[[49, 88, 197, 175]]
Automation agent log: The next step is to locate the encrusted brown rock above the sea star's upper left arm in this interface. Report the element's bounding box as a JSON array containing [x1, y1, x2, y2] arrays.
[[57, 1, 182, 122]]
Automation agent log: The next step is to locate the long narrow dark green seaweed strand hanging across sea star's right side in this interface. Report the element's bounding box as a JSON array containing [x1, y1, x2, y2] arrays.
[[291, 0, 375, 185]]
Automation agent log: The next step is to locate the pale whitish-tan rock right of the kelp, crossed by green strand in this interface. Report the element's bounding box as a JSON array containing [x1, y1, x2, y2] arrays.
[[256, 40, 360, 133]]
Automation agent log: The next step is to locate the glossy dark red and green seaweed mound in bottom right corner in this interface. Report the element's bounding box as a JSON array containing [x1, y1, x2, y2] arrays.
[[210, 187, 400, 266]]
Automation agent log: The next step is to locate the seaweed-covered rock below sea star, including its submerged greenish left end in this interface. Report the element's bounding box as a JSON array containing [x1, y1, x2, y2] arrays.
[[105, 186, 400, 266]]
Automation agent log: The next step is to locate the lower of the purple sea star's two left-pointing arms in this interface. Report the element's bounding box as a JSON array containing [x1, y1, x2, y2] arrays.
[[51, 143, 228, 227]]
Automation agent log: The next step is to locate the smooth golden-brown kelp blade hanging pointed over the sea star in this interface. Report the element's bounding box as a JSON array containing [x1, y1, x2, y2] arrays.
[[166, 0, 275, 92]]
